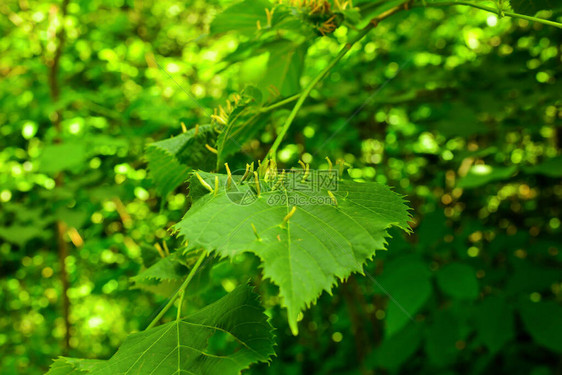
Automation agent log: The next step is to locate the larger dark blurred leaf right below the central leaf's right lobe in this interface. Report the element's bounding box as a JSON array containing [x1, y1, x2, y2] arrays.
[[377, 256, 432, 337]]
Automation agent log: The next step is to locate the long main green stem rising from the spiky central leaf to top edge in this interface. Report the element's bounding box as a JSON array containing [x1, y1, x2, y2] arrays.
[[267, 1, 411, 160]]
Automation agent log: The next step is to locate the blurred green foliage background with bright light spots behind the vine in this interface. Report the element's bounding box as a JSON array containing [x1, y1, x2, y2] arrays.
[[0, 0, 562, 375]]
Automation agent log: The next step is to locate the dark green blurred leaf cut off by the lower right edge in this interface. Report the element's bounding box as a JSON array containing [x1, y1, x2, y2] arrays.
[[519, 301, 562, 353]]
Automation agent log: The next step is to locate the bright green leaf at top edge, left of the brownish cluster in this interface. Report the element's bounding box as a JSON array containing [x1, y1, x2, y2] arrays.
[[211, 0, 273, 34]]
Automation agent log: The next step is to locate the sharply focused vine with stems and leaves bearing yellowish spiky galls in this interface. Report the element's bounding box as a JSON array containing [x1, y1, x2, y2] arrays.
[[48, 0, 562, 375]]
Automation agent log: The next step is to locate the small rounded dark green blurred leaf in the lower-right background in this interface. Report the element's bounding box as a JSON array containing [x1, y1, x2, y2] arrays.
[[437, 263, 479, 300]]
